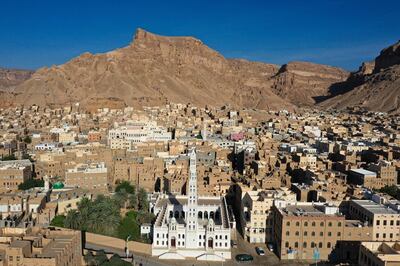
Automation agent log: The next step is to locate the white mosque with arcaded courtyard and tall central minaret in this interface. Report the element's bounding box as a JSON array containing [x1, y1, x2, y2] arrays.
[[152, 149, 233, 261]]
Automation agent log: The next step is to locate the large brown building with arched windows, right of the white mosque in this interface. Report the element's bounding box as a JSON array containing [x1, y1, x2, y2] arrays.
[[273, 202, 372, 260]]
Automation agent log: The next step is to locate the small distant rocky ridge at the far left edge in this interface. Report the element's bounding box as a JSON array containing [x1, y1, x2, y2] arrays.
[[0, 67, 33, 91]]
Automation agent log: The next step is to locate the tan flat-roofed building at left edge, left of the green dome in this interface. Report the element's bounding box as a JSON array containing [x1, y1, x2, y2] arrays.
[[0, 160, 32, 190]]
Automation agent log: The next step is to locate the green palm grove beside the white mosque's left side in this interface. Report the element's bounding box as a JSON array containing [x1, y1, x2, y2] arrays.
[[51, 181, 154, 242]]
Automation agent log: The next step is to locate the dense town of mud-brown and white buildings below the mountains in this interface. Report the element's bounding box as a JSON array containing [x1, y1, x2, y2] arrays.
[[0, 103, 400, 266]]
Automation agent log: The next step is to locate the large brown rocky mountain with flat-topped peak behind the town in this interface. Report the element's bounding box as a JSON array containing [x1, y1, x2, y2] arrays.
[[4, 29, 348, 110]]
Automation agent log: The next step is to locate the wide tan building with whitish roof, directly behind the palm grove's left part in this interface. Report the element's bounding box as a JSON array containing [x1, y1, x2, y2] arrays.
[[65, 162, 108, 191]]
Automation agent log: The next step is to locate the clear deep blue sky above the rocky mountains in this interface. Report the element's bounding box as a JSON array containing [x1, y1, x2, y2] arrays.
[[0, 0, 400, 70]]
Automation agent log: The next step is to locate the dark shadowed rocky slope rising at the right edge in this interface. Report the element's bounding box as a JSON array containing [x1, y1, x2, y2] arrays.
[[319, 41, 400, 113]]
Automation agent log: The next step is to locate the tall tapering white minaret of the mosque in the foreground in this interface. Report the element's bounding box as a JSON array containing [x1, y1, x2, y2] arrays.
[[185, 148, 198, 248]]
